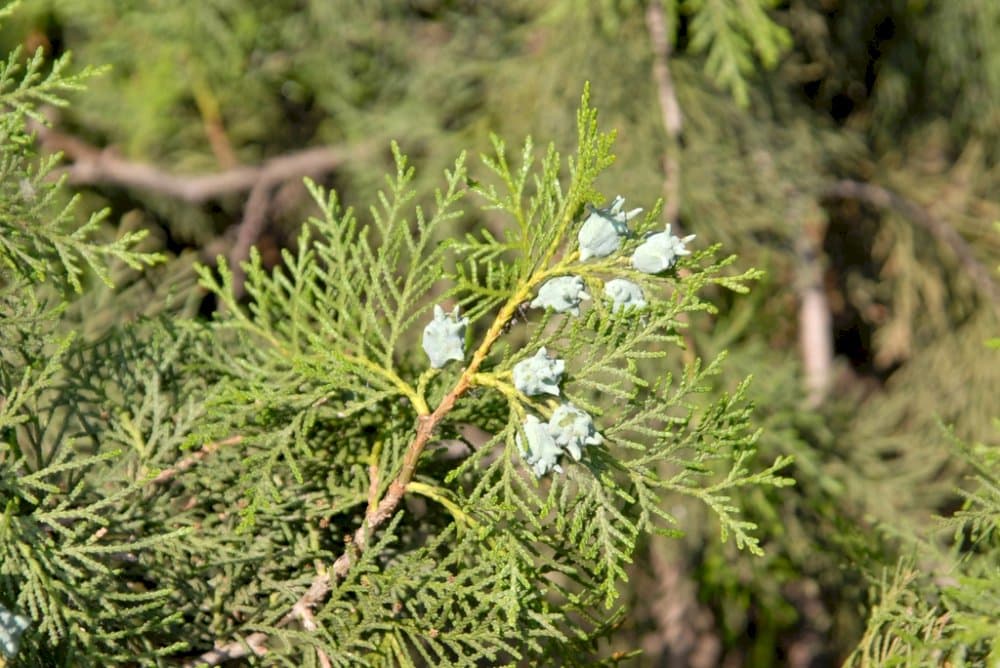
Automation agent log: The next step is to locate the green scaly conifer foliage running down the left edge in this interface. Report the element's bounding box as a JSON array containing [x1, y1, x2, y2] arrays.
[[0, 11, 182, 665]]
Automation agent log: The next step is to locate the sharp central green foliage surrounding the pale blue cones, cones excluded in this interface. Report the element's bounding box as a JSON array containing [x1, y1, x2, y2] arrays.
[[178, 87, 788, 663]]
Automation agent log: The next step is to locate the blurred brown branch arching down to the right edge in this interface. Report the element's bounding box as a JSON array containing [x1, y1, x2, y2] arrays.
[[822, 179, 1000, 302]]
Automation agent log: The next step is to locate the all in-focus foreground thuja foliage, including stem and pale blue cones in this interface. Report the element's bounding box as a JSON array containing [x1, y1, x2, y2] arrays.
[[0, 51, 788, 666]]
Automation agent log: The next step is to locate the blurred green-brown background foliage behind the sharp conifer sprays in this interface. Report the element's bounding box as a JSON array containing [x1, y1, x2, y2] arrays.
[[0, 0, 1000, 666]]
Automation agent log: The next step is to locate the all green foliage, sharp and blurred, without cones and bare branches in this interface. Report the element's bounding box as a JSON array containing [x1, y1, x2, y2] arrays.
[[0, 0, 1000, 666]]
